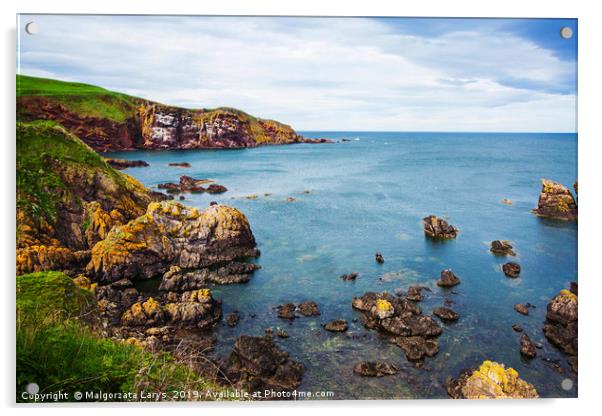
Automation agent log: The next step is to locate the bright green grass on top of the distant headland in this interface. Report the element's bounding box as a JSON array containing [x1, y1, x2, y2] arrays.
[[17, 75, 140, 123]]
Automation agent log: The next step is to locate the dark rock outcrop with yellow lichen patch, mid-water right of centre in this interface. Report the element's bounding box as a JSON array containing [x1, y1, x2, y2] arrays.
[[352, 292, 441, 361]]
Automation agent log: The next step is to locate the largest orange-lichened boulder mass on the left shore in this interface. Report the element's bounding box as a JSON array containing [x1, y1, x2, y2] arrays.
[[86, 201, 259, 282]]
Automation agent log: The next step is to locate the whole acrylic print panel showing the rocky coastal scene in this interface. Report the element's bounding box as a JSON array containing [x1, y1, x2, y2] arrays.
[[16, 15, 578, 402]]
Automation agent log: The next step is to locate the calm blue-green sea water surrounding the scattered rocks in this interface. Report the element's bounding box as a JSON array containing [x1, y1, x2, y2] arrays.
[[104, 132, 577, 399]]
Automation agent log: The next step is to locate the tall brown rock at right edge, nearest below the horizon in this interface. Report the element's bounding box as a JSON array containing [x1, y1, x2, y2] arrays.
[[533, 179, 577, 221]]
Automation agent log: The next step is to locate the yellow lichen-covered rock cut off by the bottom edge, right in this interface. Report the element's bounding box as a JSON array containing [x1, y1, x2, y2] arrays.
[[447, 360, 539, 399]]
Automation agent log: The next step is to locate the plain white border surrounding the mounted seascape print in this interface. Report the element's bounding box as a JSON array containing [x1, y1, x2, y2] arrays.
[[0, 0, 602, 416]]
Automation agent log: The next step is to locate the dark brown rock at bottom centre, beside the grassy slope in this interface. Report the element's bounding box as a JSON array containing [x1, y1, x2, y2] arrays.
[[222, 335, 304, 394]]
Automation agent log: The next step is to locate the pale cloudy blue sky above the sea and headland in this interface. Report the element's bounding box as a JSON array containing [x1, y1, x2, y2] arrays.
[[18, 15, 577, 132]]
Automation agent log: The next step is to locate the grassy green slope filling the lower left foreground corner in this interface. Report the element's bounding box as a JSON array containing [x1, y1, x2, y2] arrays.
[[16, 272, 232, 401]]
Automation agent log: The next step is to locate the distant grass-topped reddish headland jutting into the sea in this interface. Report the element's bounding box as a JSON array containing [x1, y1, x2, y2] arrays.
[[17, 76, 303, 151]]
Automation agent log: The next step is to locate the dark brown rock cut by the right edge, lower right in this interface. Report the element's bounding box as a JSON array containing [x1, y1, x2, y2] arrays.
[[543, 289, 579, 372]]
